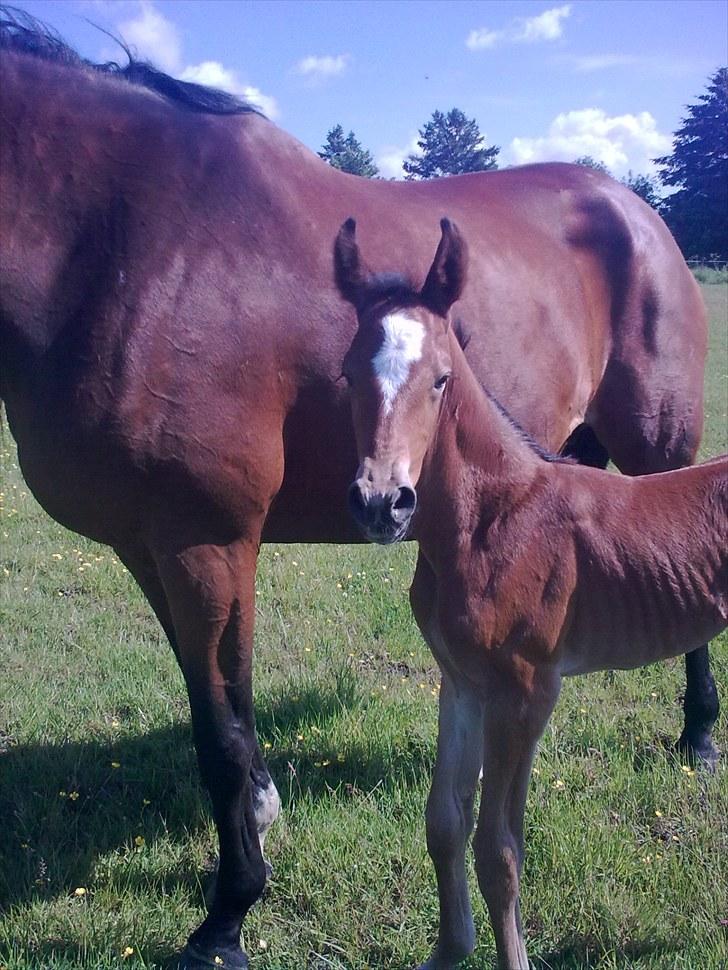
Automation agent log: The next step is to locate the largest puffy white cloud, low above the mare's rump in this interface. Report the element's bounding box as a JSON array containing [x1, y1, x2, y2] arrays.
[[503, 108, 672, 176]]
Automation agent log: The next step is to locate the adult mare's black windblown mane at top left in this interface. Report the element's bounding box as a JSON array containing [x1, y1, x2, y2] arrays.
[[0, 5, 262, 115]]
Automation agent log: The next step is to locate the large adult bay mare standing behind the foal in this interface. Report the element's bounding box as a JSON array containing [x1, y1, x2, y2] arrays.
[[0, 11, 718, 967]]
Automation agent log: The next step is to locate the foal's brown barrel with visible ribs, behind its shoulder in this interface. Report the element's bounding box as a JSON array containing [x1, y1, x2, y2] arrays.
[[555, 466, 728, 673]]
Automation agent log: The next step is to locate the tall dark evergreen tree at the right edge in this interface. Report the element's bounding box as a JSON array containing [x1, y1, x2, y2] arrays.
[[655, 67, 728, 259]]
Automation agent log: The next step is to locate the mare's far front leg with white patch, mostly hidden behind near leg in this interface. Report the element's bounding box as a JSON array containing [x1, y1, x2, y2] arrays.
[[115, 543, 281, 876]]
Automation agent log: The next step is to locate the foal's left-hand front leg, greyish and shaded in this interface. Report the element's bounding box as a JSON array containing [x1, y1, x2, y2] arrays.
[[420, 673, 483, 970]]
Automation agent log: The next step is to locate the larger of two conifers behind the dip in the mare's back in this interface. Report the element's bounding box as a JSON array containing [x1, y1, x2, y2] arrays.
[[402, 108, 500, 180]]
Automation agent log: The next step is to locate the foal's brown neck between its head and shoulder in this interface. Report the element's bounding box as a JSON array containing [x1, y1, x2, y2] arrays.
[[417, 337, 541, 555]]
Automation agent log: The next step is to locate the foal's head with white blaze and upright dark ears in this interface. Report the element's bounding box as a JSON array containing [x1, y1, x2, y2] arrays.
[[334, 219, 467, 544]]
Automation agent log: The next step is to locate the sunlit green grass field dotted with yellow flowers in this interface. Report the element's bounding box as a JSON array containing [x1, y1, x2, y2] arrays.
[[0, 284, 728, 970]]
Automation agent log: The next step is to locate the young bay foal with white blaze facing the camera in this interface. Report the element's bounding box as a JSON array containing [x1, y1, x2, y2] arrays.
[[335, 219, 728, 970]]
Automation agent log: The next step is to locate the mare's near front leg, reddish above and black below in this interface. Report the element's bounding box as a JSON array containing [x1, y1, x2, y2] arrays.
[[156, 538, 268, 970]]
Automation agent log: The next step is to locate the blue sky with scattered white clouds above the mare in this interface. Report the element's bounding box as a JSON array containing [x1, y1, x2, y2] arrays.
[[16, 0, 728, 177]]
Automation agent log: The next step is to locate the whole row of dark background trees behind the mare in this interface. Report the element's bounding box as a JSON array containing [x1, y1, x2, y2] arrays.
[[319, 67, 728, 260]]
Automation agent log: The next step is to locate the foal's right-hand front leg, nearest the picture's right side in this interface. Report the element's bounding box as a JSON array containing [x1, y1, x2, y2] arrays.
[[474, 674, 560, 970]]
